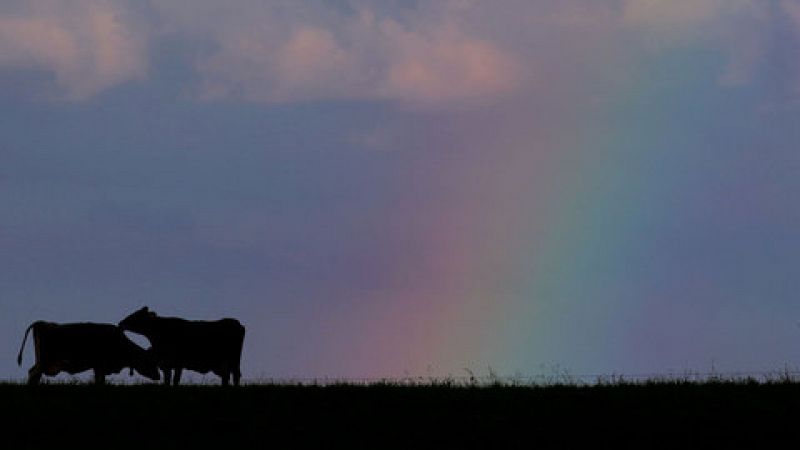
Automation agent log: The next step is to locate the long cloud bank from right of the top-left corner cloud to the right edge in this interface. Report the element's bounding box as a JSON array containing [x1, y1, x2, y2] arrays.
[[148, 0, 792, 107]]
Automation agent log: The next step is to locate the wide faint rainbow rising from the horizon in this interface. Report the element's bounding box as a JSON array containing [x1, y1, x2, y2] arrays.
[[355, 51, 764, 376]]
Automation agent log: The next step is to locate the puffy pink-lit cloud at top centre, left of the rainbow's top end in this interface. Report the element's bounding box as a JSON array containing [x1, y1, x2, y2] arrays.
[[191, 5, 519, 103]]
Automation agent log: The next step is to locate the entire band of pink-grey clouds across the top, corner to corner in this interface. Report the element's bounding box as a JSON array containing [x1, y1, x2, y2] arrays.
[[0, 0, 800, 103]]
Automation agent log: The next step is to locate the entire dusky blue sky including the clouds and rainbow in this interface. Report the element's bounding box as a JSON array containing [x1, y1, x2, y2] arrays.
[[0, 0, 800, 379]]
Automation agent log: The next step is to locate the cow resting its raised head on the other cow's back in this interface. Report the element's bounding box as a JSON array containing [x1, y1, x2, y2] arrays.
[[119, 306, 244, 386]]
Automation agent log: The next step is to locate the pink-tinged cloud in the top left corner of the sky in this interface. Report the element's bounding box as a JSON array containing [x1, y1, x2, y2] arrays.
[[0, 0, 147, 99]]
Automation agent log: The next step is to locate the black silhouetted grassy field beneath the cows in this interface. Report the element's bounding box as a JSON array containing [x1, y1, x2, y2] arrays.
[[0, 380, 800, 449]]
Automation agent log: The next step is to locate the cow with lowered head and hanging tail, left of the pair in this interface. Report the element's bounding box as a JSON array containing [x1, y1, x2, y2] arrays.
[[17, 320, 160, 385]]
